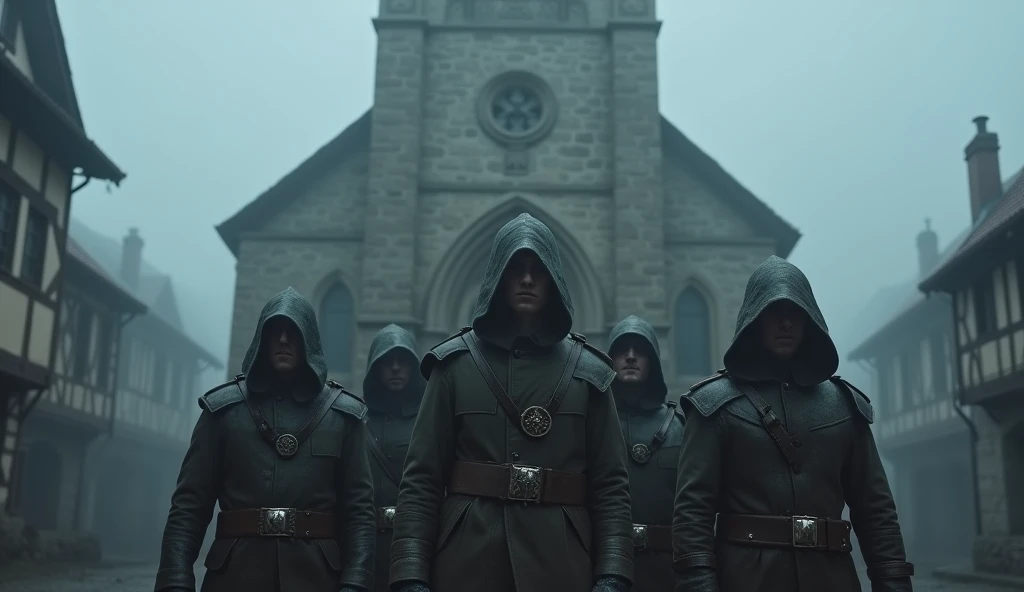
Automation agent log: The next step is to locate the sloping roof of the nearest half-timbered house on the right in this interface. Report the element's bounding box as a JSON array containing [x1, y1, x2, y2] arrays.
[[920, 163, 1024, 292]]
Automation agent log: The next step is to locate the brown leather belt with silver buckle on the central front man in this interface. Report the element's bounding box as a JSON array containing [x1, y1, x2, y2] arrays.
[[447, 461, 587, 506]]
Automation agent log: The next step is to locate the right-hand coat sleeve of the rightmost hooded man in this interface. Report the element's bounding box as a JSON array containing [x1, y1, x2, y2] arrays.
[[843, 413, 913, 590]]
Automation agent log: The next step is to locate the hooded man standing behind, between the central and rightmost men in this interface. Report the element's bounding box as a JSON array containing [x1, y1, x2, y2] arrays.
[[608, 315, 683, 592]]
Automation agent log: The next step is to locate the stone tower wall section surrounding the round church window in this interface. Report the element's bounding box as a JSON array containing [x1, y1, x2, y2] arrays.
[[422, 31, 611, 186]]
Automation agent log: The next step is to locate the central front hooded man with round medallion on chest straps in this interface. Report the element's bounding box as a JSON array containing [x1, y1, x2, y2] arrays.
[[391, 214, 633, 592]]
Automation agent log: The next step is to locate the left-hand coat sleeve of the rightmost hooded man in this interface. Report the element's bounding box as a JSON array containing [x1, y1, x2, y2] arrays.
[[672, 408, 725, 592]]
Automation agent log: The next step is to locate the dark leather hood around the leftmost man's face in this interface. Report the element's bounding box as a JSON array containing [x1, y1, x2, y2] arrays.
[[242, 286, 327, 395]]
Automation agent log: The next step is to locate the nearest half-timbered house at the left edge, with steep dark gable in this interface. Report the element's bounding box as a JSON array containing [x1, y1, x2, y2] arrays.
[[0, 0, 125, 509]]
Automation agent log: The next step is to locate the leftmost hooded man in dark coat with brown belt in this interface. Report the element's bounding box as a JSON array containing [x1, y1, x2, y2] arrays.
[[156, 288, 375, 592]]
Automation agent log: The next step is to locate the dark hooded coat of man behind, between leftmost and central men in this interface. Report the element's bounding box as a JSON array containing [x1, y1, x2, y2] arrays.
[[362, 325, 426, 592]]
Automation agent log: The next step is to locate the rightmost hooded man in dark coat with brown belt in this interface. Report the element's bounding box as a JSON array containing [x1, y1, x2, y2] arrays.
[[672, 257, 913, 592]]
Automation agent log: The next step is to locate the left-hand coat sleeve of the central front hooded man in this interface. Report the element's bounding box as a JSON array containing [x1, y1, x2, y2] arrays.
[[389, 365, 455, 586]]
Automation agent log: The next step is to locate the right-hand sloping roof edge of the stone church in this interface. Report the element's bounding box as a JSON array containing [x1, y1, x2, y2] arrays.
[[662, 116, 800, 257]]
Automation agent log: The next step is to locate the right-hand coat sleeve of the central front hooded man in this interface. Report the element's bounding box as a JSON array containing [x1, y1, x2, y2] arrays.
[[587, 385, 633, 582]]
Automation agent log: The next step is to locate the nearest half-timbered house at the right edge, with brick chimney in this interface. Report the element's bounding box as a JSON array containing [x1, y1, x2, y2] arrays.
[[920, 117, 1024, 576]]
